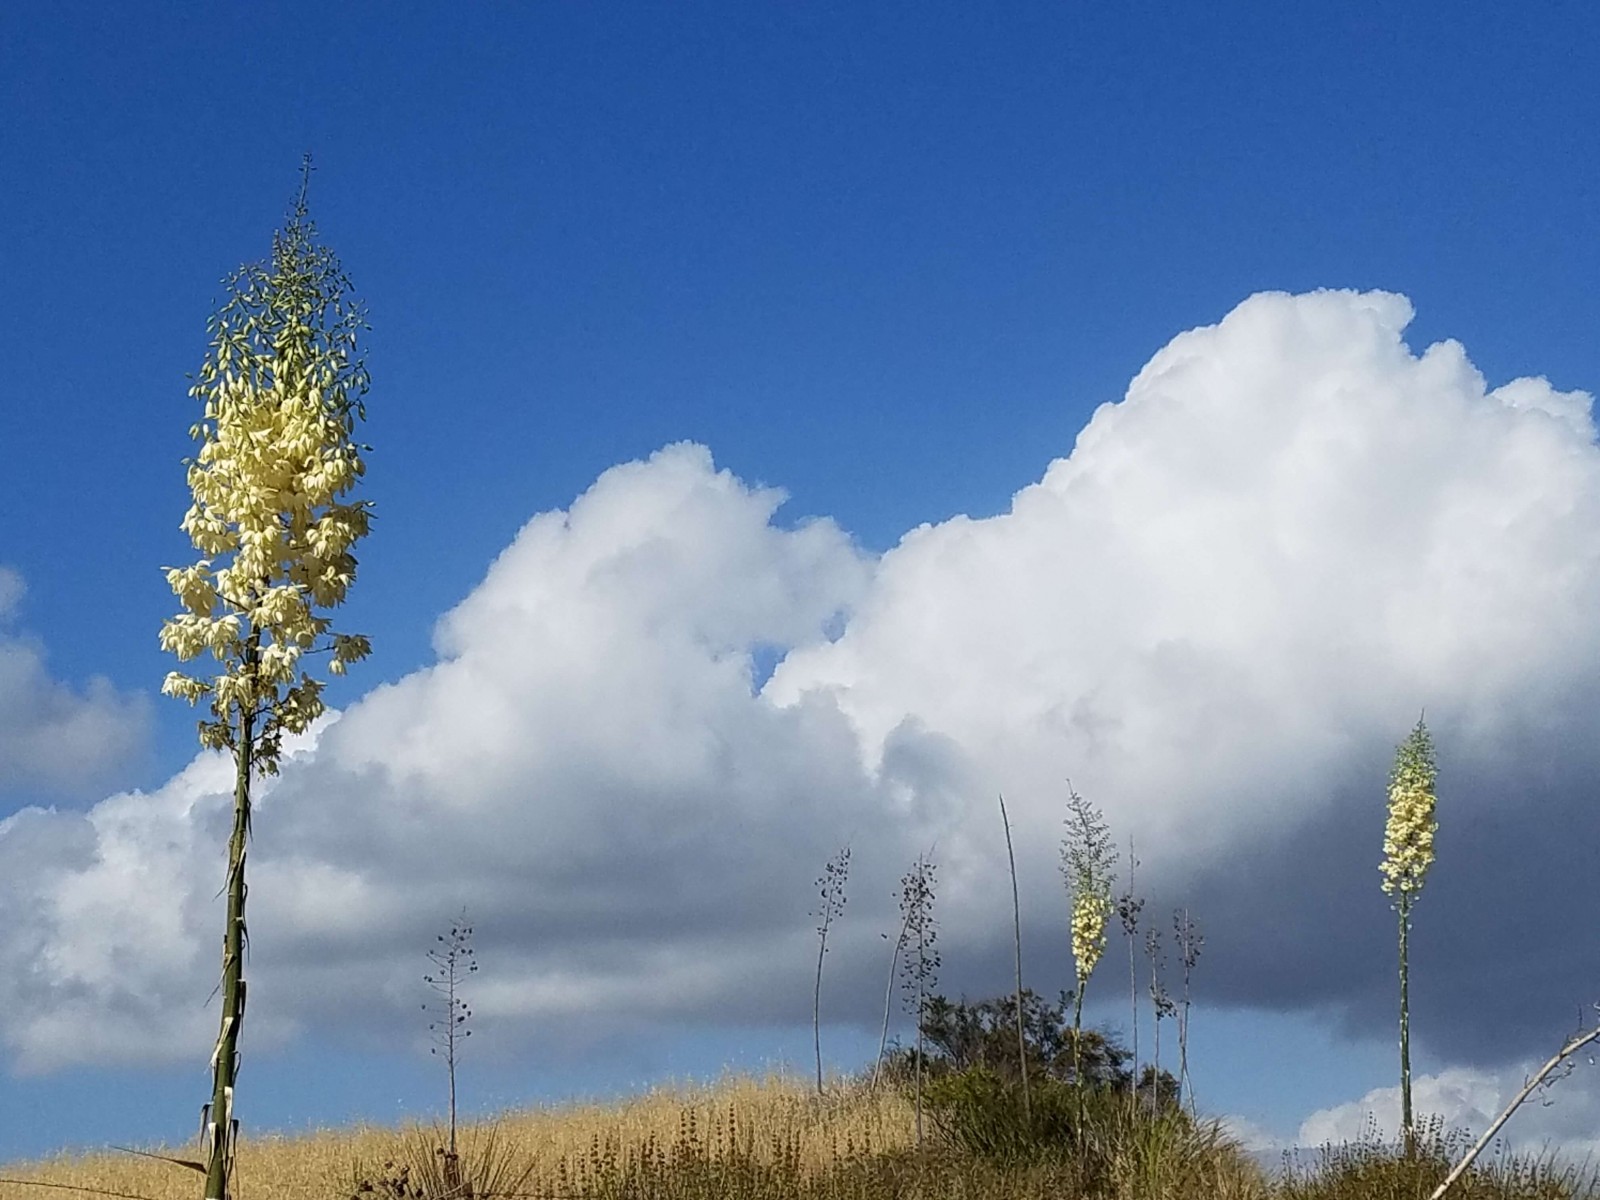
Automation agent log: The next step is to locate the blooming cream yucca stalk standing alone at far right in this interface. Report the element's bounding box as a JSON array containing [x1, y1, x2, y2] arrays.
[[1379, 717, 1438, 1158]]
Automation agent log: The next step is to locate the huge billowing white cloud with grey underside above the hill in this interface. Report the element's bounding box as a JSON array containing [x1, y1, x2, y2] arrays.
[[0, 291, 1600, 1164]]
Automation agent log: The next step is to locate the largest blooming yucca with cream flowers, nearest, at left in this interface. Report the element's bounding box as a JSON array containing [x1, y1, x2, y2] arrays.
[[162, 158, 370, 1200]]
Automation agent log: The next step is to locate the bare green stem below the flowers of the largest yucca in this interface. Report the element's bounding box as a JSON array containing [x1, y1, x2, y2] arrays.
[[202, 684, 259, 1200]]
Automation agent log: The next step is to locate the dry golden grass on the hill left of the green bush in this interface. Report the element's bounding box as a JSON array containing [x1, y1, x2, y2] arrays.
[[0, 1075, 914, 1200]]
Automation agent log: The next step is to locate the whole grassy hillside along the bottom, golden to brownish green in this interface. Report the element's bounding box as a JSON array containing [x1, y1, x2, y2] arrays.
[[0, 1078, 1600, 1200]]
